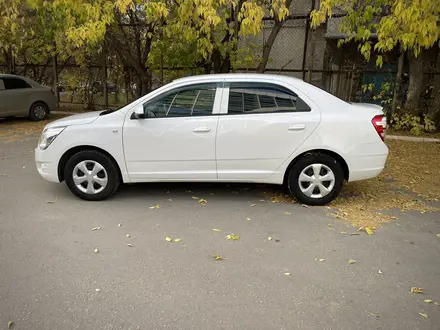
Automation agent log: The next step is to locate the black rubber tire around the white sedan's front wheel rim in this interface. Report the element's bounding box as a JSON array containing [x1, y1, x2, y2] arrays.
[[64, 150, 120, 201]]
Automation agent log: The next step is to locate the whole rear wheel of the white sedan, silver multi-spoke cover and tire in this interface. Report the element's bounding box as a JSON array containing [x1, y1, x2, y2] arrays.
[[287, 153, 344, 205]]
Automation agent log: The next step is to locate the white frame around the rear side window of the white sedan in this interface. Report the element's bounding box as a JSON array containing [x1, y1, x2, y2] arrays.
[[221, 79, 312, 116]]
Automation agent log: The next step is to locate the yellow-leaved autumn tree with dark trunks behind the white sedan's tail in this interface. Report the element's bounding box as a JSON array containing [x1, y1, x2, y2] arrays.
[[311, 0, 440, 120]]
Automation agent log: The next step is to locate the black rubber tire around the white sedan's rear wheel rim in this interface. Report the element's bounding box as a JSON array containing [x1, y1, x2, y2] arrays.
[[287, 153, 344, 205]]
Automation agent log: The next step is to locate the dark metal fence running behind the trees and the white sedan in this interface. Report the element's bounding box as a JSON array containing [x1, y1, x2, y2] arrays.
[[0, 0, 440, 113]]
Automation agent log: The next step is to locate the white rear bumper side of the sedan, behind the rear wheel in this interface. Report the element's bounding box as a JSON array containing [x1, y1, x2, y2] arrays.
[[348, 153, 388, 182]]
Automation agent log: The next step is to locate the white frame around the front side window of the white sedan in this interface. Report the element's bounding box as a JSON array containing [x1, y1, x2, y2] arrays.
[[138, 80, 223, 120]]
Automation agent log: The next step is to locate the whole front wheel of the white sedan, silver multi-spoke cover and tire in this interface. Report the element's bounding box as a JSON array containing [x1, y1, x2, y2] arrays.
[[64, 150, 120, 201]]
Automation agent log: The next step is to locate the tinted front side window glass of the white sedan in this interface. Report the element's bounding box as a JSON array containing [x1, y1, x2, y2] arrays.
[[144, 84, 217, 118]]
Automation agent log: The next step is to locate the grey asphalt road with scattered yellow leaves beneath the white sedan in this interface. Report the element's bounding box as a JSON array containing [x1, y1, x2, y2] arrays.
[[0, 127, 440, 330]]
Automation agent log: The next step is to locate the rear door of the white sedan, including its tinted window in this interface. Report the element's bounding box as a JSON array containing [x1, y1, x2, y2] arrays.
[[216, 83, 320, 180]]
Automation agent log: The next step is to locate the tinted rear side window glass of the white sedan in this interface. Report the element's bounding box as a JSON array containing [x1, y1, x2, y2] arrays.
[[228, 82, 310, 115]]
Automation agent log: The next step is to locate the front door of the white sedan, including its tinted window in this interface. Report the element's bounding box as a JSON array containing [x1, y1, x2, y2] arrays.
[[124, 84, 219, 182]]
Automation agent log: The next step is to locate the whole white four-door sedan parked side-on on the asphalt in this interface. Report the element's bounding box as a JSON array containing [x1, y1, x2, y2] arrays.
[[35, 74, 388, 205]]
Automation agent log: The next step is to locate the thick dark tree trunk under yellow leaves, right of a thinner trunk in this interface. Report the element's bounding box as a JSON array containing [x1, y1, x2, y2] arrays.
[[405, 51, 423, 116]]
